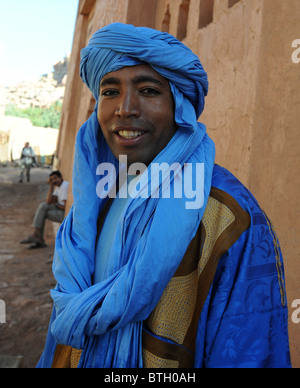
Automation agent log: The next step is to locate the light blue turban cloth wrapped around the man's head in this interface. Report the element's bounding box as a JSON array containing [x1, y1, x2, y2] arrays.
[[80, 23, 208, 118]]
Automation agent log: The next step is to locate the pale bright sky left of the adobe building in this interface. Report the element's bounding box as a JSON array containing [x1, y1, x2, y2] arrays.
[[0, 0, 79, 86]]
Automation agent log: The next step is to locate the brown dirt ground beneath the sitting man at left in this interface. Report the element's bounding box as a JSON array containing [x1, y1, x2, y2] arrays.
[[0, 167, 55, 368]]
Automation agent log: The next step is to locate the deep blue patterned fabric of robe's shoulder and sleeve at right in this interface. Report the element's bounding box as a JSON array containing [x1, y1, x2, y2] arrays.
[[195, 166, 291, 368]]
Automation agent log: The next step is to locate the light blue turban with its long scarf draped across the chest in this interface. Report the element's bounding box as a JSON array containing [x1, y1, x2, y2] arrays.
[[38, 23, 215, 368]]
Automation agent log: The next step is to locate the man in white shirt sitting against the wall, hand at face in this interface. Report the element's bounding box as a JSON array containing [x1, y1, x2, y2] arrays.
[[20, 171, 69, 249]]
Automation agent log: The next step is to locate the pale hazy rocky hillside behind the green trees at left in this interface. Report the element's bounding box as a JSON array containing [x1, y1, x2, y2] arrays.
[[5, 56, 69, 109]]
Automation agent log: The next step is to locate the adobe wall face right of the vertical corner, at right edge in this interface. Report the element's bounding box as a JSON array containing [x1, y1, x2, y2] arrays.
[[249, 0, 300, 367]]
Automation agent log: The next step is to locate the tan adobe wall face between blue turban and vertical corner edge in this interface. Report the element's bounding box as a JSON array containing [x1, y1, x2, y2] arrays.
[[185, 0, 263, 186]]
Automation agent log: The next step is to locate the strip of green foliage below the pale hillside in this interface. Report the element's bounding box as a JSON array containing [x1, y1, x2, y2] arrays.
[[5, 101, 62, 128]]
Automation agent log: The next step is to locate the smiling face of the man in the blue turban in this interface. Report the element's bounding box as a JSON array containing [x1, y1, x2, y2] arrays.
[[98, 65, 176, 166]]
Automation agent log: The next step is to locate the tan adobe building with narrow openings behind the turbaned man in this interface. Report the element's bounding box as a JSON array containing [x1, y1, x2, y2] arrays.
[[56, 0, 300, 367]]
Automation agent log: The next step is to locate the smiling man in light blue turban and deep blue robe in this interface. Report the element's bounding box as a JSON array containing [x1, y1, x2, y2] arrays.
[[38, 23, 290, 368]]
